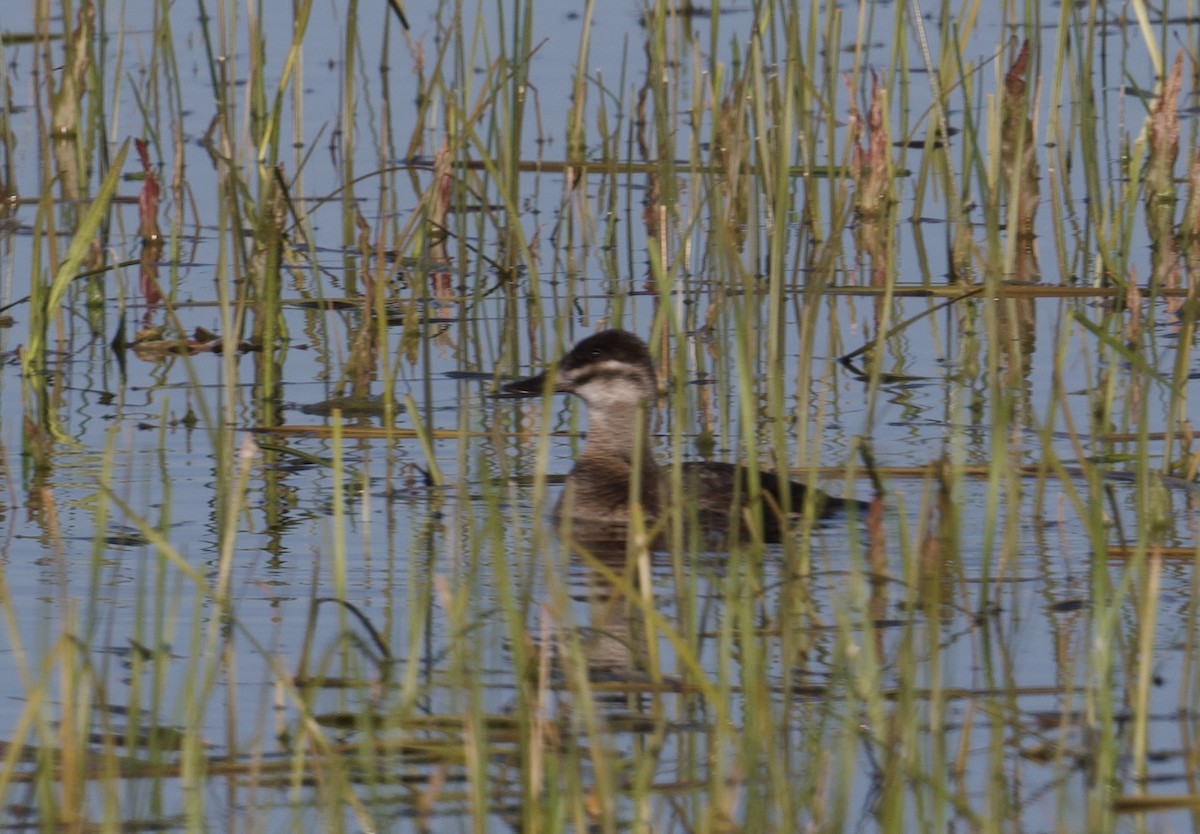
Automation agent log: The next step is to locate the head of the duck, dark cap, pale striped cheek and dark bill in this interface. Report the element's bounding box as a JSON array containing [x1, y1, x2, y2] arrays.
[[500, 330, 658, 408]]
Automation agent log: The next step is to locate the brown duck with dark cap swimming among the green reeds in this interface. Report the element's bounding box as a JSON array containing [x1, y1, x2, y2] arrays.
[[500, 330, 868, 542]]
